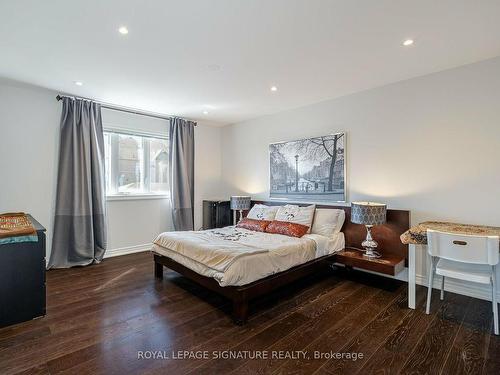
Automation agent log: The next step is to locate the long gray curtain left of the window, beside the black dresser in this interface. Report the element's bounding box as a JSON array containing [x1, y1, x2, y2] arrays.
[[48, 98, 106, 268]]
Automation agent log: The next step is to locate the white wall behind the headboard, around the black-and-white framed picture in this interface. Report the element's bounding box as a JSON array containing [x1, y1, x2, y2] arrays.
[[222, 58, 500, 300]]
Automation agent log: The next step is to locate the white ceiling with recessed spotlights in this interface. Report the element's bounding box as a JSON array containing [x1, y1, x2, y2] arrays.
[[0, 0, 500, 124]]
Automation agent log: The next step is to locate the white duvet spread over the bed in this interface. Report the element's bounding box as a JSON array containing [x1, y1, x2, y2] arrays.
[[152, 227, 344, 286]]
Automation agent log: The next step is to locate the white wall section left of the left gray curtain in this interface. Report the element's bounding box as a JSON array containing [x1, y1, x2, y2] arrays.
[[0, 80, 61, 256]]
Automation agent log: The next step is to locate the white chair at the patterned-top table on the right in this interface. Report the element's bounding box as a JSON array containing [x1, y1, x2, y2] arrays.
[[426, 229, 500, 335]]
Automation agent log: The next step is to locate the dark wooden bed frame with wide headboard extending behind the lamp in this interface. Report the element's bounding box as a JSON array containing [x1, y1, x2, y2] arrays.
[[154, 201, 409, 325]]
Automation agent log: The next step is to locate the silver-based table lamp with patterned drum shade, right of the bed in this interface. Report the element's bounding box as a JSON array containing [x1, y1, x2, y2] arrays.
[[351, 202, 387, 258]]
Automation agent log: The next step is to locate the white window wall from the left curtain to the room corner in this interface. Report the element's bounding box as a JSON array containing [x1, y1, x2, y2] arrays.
[[102, 109, 221, 254]]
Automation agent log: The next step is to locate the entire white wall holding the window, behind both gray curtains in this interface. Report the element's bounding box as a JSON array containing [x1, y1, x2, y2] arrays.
[[0, 79, 221, 255]]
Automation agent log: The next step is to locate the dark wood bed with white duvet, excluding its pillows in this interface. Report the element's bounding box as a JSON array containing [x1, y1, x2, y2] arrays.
[[152, 202, 410, 324]]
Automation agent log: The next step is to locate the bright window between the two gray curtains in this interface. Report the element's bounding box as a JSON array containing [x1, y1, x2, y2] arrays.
[[104, 131, 168, 196]]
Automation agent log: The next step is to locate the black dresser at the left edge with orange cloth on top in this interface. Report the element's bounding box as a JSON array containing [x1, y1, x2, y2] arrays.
[[0, 215, 45, 327]]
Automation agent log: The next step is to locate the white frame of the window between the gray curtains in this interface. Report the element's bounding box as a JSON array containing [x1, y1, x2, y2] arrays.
[[103, 126, 170, 201]]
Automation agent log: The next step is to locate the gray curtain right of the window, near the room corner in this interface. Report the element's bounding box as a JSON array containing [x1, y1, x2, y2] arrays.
[[168, 118, 196, 230]]
